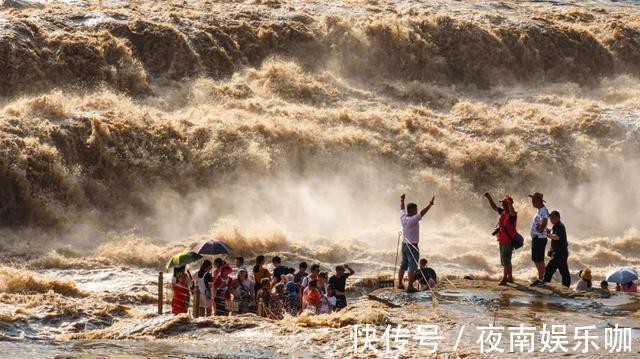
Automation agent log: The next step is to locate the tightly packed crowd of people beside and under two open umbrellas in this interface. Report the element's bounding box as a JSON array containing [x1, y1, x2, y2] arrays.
[[172, 255, 355, 319]]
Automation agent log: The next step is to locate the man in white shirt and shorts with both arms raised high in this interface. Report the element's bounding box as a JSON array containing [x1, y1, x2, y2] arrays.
[[398, 193, 436, 293]]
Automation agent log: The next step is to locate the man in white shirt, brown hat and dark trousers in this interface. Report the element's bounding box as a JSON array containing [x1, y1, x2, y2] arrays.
[[529, 192, 549, 286]]
